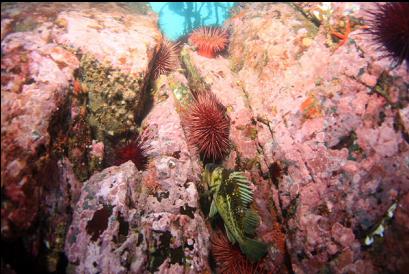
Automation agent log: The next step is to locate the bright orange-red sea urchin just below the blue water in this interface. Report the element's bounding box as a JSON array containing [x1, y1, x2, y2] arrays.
[[189, 27, 228, 58]]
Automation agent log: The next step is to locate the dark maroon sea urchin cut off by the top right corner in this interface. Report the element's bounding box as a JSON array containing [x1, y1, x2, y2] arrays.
[[368, 2, 409, 70]]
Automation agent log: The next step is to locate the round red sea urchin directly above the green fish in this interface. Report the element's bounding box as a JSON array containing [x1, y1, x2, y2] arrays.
[[183, 91, 230, 160]]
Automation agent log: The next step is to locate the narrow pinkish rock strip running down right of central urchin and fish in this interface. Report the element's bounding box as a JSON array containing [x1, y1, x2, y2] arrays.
[[185, 45, 286, 271]]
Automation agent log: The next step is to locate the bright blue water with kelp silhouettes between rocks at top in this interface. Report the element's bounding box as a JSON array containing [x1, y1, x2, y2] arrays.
[[149, 2, 235, 41]]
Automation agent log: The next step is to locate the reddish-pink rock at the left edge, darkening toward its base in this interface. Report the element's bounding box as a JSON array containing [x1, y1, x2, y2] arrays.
[[1, 18, 79, 236]]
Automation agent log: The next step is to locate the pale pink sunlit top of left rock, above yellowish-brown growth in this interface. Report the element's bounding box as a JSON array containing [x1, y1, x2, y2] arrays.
[[53, 3, 161, 76]]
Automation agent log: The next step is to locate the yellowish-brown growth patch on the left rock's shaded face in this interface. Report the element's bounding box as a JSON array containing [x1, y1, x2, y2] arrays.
[[80, 55, 144, 140]]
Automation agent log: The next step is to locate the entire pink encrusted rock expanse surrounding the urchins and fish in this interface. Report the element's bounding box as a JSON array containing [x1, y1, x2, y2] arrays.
[[1, 3, 409, 273]]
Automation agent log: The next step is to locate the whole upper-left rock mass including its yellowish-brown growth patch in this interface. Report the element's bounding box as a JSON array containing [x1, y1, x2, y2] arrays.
[[1, 3, 162, 272]]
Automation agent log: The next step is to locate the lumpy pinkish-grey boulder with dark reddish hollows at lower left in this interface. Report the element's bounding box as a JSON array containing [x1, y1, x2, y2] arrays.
[[65, 161, 147, 273]]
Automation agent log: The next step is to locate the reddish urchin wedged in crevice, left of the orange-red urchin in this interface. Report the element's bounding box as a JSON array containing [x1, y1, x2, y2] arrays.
[[152, 39, 179, 79]]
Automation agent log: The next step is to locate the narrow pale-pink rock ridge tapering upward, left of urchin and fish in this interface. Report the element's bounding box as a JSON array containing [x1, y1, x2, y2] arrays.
[[138, 72, 210, 273]]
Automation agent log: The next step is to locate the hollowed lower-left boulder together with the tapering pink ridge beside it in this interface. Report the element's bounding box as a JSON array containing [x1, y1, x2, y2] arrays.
[[66, 70, 209, 273]]
